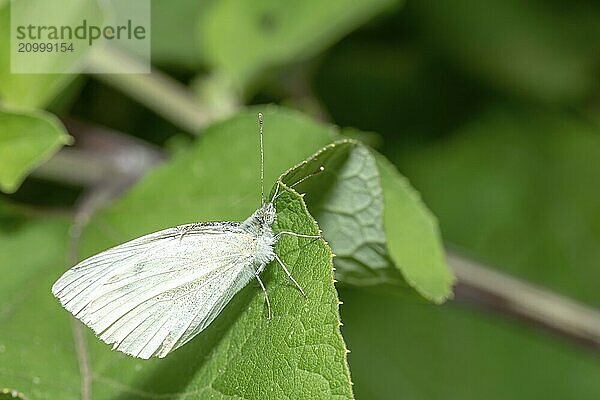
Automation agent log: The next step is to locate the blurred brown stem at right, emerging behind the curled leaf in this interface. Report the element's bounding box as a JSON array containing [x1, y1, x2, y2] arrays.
[[448, 252, 600, 350]]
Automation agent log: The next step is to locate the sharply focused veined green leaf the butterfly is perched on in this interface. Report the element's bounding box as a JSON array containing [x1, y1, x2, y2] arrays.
[[81, 186, 352, 399]]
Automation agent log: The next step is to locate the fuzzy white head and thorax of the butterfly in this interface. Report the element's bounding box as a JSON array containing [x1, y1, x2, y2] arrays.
[[242, 203, 276, 265]]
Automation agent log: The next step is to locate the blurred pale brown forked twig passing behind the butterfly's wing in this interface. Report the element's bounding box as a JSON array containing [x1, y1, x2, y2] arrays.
[[57, 121, 164, 400]]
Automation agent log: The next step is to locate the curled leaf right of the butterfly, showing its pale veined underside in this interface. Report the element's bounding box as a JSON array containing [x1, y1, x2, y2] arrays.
[[285, 140, 454, 303]]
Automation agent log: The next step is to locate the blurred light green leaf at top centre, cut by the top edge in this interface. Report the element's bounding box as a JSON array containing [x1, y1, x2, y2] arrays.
[[197, 0, 399, 87]]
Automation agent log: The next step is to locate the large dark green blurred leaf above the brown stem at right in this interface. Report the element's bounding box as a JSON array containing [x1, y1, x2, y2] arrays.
[[394, 109, 600, 306]]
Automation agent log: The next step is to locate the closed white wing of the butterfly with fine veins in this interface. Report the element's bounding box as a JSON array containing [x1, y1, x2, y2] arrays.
[[52, 222, 256, 359]]
